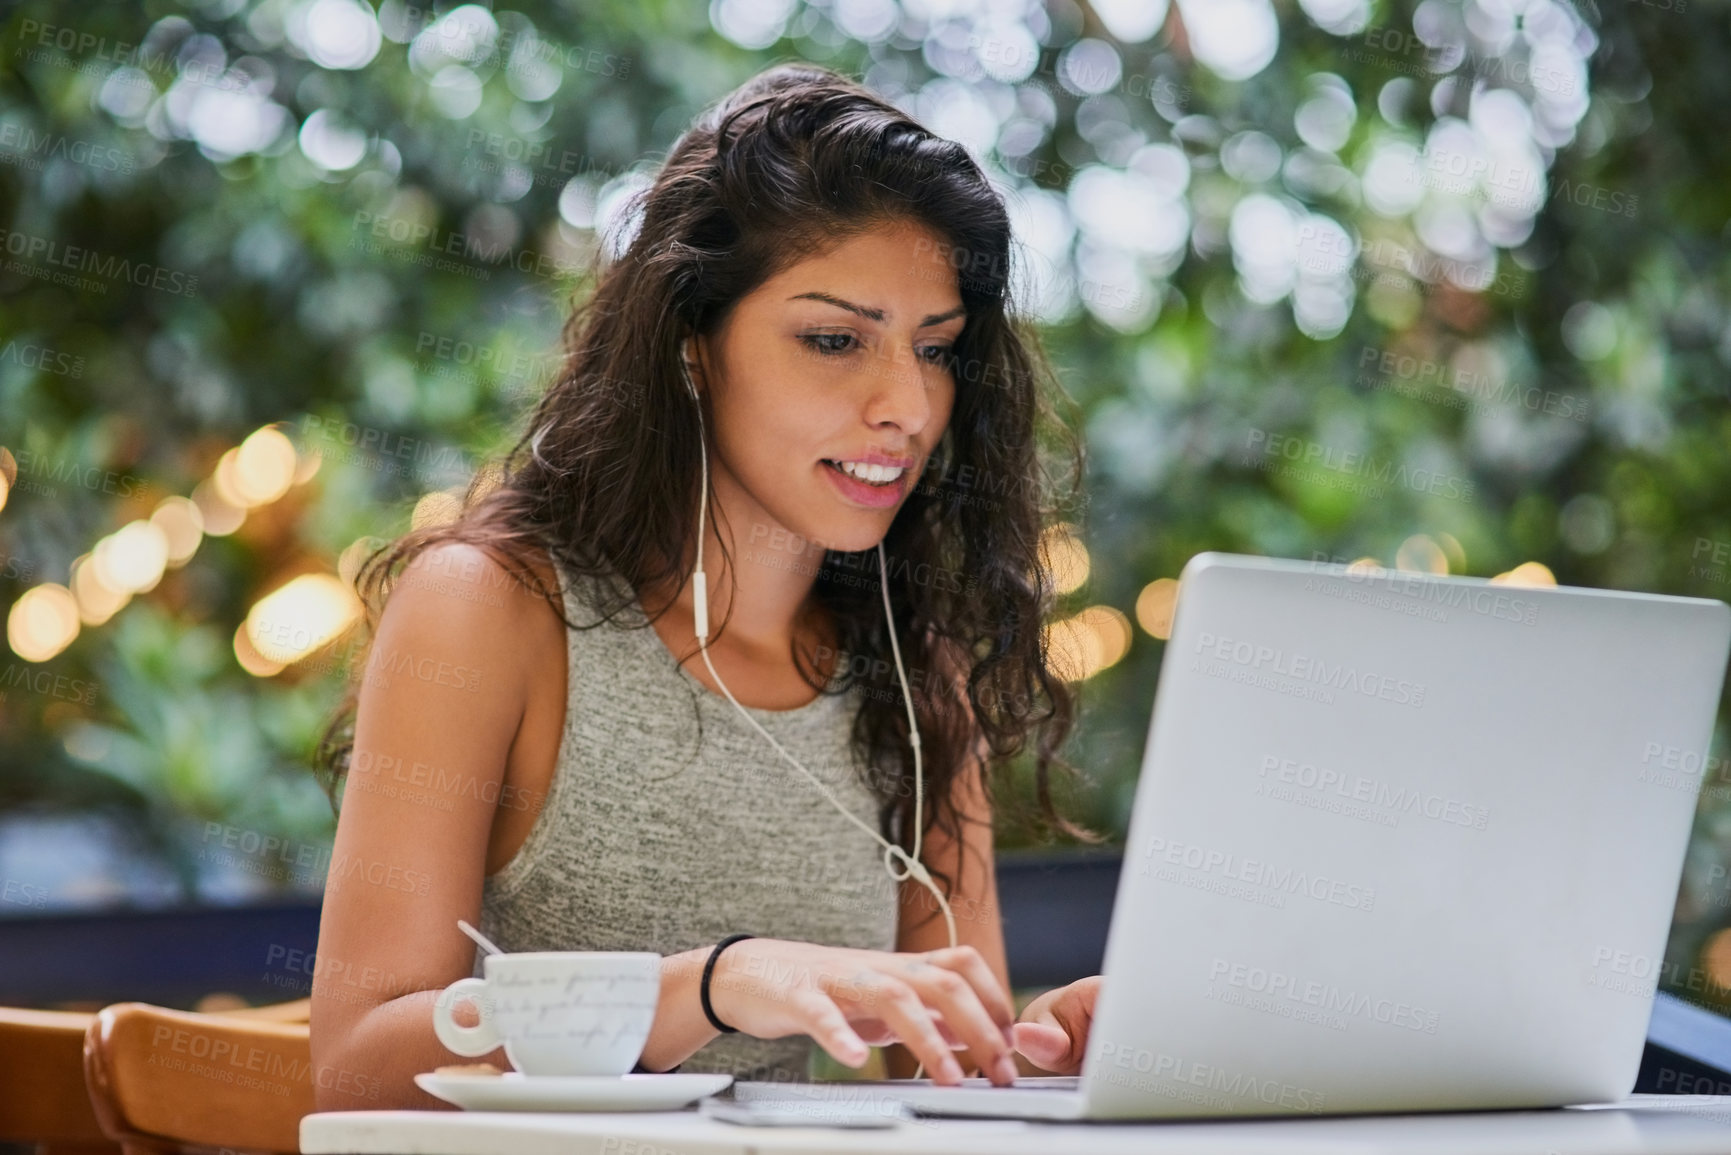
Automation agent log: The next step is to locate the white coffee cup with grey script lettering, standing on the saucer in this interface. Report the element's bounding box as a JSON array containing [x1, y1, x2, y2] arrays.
[[433, 951, 661, 1075]]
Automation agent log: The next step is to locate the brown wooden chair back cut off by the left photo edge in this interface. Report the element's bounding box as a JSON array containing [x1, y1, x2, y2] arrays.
[[0, 1006, 119, 1155]]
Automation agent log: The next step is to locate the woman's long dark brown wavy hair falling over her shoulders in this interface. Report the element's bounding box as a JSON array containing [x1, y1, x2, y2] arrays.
[[317, 64, 1094, 914]]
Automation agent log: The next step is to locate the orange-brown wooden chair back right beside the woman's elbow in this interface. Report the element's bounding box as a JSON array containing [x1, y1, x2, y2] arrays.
[[85, 1003, 313, 1152]]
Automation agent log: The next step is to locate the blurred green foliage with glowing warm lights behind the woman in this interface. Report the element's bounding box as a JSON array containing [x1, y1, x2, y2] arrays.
[[0, 0, 1731, 997]]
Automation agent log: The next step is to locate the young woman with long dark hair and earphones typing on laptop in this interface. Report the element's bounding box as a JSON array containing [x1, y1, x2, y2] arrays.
[[312, 66, 1096, 1110]]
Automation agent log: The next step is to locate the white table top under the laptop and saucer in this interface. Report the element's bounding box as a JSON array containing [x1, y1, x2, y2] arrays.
[[301, 1096, 1731, 1155]]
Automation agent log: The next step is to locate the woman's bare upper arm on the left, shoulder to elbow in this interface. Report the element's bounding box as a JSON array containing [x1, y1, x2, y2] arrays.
[[312, 545, 543, 1110]]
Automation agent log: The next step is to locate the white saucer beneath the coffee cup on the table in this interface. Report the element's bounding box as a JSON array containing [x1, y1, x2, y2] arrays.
[[415, 1070, 734, 1112]]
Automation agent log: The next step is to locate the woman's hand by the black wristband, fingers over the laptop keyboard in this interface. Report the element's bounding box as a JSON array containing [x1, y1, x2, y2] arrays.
[[710, 939, 1016, 1086]]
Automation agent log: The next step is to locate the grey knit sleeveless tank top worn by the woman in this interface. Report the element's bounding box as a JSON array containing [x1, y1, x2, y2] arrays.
[[476, 554, 897, 1081]]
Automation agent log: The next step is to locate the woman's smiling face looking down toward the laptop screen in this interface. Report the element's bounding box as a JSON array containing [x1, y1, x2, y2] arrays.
[[696, 223, 964, 551]]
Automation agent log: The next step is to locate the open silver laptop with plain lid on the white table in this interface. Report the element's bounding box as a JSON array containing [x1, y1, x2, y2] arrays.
[[736, 554, 1731, 1119]]
